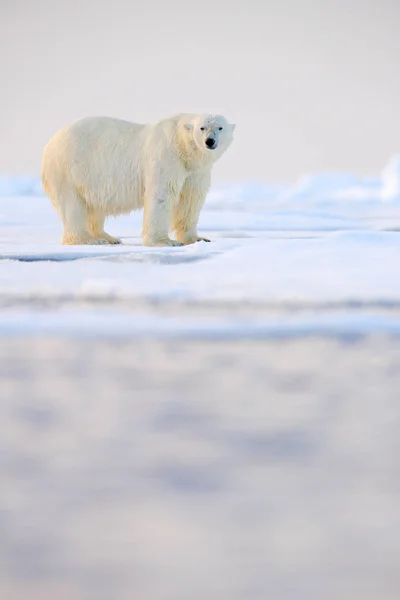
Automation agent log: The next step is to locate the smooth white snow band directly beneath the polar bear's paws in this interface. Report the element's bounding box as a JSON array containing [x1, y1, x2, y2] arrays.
[[4, 229, 400, 303]]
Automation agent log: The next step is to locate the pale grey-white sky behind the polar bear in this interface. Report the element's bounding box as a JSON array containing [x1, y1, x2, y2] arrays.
[[0, 0, 400, 182]]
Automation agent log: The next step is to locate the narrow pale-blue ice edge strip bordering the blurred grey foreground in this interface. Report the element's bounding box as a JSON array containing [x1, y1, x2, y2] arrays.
[[0, 309, 400, 340]]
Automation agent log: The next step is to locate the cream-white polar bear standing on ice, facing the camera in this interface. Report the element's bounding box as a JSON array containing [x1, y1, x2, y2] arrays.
[[42, 114, 235, 246]]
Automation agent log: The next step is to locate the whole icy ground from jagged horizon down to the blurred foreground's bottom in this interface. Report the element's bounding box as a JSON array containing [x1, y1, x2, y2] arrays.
[[0, 158, 400, 600]]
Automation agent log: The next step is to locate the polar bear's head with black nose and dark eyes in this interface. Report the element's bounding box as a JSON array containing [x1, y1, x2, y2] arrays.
[[185, 115, 235, 158]]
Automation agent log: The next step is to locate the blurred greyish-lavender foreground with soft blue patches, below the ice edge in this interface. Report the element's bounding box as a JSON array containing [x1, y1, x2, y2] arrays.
[[0, 338, 400, 600]]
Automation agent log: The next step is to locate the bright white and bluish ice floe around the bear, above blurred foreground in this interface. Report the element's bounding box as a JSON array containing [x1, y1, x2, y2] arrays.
[[0, 157, 400, 335]]
